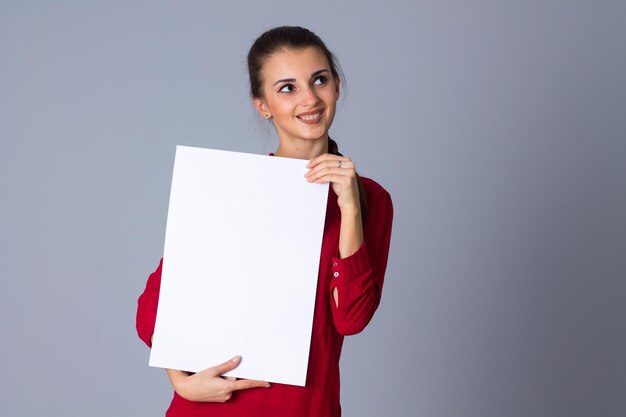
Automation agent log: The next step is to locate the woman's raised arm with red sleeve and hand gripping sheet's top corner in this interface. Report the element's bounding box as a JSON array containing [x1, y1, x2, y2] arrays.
[[306, 154, 393, 335]]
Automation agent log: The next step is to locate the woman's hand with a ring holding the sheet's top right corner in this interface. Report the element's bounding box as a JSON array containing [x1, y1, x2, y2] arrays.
[[304, 153, 360, 212]]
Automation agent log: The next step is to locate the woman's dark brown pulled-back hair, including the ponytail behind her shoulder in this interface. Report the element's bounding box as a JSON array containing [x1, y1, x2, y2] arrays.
[[248, 26, 368, 224]]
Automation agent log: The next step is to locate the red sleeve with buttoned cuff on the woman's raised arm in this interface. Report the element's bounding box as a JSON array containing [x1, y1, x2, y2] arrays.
[[330, 187, 393, 336]]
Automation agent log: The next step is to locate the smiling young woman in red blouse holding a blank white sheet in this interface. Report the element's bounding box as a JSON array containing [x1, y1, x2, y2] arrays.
[[137, 27, 393, 417]]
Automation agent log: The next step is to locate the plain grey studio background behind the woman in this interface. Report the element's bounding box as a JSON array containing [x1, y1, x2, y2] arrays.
[[0, 0, 626, 417]]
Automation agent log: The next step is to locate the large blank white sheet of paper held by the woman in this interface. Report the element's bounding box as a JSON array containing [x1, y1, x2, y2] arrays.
[[150, 146, 328, 386]]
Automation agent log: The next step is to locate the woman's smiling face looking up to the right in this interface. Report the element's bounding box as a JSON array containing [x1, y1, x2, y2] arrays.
[[254, 47, 339, 147]]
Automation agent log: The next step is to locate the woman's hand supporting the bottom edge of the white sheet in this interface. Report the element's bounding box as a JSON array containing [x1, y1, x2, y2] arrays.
[[167, 356, 270, 403]]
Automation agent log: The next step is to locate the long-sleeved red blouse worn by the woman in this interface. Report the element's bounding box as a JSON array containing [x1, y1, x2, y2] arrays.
[[137, 177, 393, 417]]
